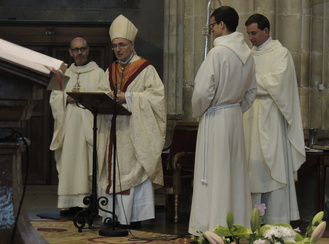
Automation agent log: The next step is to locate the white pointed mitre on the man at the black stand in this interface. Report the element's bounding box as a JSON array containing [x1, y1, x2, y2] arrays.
[[110, 15, 138, 42]]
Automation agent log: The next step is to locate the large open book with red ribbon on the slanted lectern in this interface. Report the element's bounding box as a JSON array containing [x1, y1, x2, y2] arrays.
[[0, 38, 69, 90]]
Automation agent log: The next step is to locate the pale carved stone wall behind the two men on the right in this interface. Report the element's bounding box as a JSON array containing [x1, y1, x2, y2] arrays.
[[164, 0, 329, 137]]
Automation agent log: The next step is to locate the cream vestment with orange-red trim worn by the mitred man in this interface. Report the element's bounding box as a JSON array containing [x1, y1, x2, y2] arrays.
[[98, 54, 166, 224]]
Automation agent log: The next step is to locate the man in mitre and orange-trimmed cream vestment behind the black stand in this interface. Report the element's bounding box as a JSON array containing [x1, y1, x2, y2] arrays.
[[98, 15, 166, 228]]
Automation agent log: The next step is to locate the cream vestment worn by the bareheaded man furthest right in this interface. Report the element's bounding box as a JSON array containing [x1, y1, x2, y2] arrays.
[[244, 40, 305, 224]]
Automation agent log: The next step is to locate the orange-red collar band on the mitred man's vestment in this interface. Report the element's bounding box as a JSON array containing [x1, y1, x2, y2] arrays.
[[109, 55, 150, 92]]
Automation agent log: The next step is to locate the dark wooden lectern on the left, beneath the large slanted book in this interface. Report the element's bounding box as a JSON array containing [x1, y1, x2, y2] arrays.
[[0, 53, 66, 244]]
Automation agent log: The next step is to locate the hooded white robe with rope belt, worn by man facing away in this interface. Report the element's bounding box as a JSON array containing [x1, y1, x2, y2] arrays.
[[189, 32, 256, 235]]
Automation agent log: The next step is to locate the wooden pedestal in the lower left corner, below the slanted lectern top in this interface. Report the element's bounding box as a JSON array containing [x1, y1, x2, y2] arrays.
[[0, 140, 48, 244]]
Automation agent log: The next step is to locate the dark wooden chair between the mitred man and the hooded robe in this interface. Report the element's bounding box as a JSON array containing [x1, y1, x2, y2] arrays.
[[159, 121, 198, 223]]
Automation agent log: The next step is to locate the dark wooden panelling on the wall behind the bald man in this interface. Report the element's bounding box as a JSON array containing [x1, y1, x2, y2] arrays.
[[0, 20, 114, 184]]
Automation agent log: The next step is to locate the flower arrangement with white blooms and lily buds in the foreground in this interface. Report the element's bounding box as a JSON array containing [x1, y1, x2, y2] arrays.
[[192, 204, 326, 244]]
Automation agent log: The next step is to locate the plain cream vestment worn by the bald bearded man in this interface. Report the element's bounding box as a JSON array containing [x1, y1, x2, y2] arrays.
[[49, 62, 109, 208]]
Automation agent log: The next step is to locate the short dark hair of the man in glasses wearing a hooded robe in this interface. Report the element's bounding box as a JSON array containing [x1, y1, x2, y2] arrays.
[[210, 6, 239, 32]]
